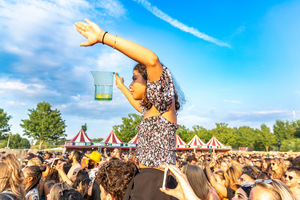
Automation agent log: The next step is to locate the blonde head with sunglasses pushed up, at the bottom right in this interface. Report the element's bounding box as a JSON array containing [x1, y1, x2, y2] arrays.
[[249, 179, 294, 200]]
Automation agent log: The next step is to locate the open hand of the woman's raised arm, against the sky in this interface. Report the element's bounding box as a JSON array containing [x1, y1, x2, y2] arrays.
[[75, 19, 105, 46]]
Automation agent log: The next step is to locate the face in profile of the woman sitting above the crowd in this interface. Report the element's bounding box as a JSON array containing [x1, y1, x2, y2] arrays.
[[129, 70, 147, 100]]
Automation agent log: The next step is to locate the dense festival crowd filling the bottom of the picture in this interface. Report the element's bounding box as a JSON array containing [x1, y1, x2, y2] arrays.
[[0, 151, 300, 200]]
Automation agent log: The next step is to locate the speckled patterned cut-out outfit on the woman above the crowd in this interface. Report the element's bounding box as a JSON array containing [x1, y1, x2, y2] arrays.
[[136, 66, 177, 167]]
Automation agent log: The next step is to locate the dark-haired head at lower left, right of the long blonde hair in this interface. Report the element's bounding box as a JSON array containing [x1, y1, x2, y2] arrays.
[[23, 166, 42, 193]]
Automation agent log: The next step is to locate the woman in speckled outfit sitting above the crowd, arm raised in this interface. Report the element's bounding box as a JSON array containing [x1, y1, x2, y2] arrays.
[[76, 19, 180, 199]]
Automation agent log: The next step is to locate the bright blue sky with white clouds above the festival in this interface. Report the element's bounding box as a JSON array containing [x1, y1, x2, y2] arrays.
[[0, 0, 300, 141]]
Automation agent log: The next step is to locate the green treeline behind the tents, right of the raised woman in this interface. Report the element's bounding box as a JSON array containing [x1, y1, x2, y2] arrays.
[[177, 120, 300, 152]]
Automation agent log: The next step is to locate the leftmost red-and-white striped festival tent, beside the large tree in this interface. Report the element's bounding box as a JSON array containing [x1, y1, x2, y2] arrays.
[[65, 129, 97, 150]]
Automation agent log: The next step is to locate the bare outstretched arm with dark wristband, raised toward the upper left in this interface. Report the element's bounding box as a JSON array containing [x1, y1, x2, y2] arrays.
[[75, 19, 162, 81]]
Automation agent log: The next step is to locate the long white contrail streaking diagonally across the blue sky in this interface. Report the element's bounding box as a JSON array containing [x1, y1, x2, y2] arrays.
[[134, 0, 230, 48]]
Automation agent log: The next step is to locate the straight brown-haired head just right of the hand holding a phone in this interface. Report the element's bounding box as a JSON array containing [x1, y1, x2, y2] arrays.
[[181, 164, 210, 199]]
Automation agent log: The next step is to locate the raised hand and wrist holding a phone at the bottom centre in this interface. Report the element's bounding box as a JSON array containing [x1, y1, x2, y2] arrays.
[[160, 165, 199, 200]]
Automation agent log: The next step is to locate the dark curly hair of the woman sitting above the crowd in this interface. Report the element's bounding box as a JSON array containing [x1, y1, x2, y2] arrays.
[[133, 63, 185, 111]]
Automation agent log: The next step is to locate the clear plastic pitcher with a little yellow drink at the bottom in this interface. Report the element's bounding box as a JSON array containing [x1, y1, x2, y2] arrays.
[[91, 71, 114, 101]]
